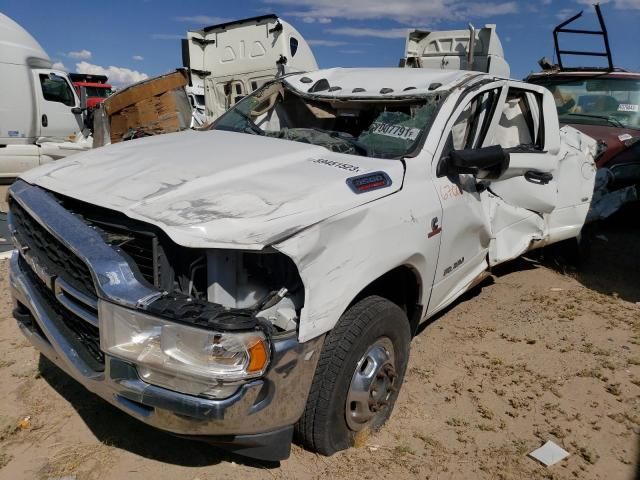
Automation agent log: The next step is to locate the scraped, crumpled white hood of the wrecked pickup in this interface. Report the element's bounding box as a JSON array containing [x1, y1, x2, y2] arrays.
[[21, 130, 404, 249]]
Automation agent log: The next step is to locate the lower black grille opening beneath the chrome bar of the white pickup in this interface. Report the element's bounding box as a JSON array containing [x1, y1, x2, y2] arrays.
[[20, 258, 104, 372]]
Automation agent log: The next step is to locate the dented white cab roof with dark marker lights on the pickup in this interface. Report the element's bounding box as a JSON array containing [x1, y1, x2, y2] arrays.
[[285, 68, 490, 98]]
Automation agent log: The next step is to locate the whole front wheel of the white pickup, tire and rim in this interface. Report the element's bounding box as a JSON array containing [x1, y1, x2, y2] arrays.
[[296, 296, 411, 455]]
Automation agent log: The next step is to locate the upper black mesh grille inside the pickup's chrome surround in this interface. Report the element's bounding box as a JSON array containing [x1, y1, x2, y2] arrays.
[[9, 201, 96, 298]]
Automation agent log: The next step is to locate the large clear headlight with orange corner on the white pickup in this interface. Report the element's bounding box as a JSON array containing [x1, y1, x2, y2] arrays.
[[98, 301, 269, 398]]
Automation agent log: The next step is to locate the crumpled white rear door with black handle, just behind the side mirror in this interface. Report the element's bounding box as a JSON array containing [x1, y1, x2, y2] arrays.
[[477, 82, 560, 265]]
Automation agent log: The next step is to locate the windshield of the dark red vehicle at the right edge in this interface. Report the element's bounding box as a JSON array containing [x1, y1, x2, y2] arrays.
[[534, 77, 640, 129]]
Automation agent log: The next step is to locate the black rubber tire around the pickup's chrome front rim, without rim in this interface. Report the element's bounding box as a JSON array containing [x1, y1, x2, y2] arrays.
[[296, 296, 411, 455]]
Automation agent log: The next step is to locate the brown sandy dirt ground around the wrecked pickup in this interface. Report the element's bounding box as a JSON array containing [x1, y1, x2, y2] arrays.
[[0, 204, 640, 480]]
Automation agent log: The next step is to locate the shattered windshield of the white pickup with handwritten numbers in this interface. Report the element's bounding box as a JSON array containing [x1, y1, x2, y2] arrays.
[[212, 81, 442, 158]]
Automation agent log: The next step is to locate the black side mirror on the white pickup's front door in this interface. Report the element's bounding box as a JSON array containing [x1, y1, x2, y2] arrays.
[[437, 145, 509, 179]]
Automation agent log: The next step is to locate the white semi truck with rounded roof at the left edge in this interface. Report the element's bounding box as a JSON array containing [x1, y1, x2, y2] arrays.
[[0, 13, 91, 179]]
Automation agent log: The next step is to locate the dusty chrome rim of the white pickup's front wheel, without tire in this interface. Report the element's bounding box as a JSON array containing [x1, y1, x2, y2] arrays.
[[345, 337, 397, 432]]
